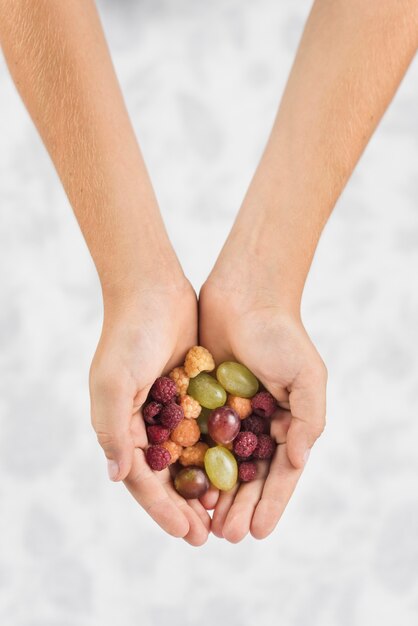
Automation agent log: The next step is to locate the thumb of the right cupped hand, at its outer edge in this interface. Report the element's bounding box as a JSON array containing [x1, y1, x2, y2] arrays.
[[287, 366, 327, 468]]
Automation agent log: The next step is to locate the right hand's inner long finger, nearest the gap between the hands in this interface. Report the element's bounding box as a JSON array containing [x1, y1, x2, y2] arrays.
[[222, 462, 268, 543]]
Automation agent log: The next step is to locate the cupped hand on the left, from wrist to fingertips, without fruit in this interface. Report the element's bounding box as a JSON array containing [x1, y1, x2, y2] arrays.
[[90, 281, 210, 545]]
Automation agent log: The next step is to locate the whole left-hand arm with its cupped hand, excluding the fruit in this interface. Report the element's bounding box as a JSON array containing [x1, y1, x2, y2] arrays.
[[0, 0, 211, 545]]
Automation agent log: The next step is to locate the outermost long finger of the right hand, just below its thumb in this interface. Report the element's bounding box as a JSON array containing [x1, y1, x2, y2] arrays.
[[250, 444, 303, 539]]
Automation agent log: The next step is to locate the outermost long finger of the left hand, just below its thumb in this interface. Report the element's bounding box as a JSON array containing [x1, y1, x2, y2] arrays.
[[124, 448, 190, 537]]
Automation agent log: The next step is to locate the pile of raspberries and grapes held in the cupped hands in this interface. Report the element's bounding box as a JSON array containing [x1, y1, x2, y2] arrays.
[[143, 346, 277, 498]]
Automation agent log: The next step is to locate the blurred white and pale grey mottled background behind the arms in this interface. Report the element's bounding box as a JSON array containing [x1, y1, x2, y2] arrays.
[[0, 0, 418, 626]]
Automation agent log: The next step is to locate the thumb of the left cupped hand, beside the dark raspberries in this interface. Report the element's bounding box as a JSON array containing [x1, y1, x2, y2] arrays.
[[90, 382, 134, 481]]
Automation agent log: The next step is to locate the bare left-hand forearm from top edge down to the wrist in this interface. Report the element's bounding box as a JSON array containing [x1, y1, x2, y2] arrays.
[[0, 0, 178, 294]]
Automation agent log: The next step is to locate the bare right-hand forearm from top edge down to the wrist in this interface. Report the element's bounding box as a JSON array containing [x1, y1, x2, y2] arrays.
[[215, 0, 418, 310]]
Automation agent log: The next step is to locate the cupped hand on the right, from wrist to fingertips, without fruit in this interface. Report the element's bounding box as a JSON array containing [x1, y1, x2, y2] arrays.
[[199, 280, 326, 543]]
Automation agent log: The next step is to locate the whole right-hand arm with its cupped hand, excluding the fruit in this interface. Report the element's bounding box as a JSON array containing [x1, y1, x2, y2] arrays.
[[199, 0, 418, 542]]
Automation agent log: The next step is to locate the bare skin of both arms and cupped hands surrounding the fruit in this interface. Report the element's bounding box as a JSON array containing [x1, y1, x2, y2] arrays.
[[0, 0, 417, 545]]
